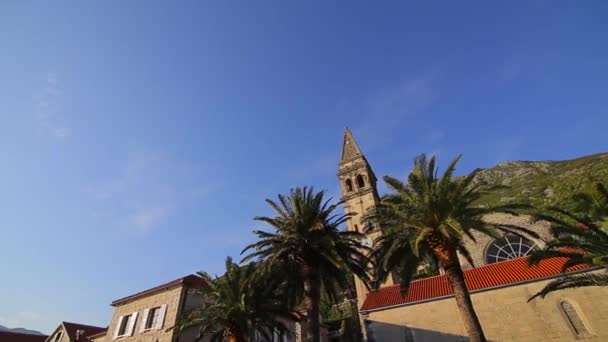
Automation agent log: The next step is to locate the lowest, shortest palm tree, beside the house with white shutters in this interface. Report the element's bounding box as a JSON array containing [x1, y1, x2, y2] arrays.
[[174, 257, 293, 342]]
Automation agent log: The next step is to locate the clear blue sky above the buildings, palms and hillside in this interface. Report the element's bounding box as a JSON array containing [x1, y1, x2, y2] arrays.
[[0, 1, 608, 333]]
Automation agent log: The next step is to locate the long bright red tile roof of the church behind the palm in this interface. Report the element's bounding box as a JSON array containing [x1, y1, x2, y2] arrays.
[[361, 257, 589, 311]]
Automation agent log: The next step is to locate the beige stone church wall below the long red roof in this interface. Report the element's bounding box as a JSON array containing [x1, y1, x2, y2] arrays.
[[366, 280, 608, 342]]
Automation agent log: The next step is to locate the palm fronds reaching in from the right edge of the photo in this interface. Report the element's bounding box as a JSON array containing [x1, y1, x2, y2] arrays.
[[528, 183, 608, 301]]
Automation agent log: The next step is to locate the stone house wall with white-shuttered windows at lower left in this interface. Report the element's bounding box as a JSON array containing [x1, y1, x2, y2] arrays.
[[104, 285, 183, 342]]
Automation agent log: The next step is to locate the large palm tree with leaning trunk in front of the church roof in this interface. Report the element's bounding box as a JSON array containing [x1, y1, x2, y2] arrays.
[[366, 155, 538, 342]]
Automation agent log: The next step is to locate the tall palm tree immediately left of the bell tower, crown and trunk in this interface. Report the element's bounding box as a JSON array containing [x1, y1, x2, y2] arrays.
[[243, 187, 368, 342]]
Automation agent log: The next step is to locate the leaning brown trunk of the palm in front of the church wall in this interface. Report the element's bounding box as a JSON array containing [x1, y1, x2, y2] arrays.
[[433, 246, 486, 342]]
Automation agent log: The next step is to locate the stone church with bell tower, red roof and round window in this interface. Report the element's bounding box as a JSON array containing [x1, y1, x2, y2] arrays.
[[338, 129, 608, 342]]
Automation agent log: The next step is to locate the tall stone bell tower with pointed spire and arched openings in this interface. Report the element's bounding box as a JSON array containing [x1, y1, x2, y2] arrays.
[[338, 128, 393, 307]]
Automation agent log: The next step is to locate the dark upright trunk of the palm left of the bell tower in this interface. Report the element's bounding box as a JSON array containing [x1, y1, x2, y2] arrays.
[[302, 265, 321, 342]]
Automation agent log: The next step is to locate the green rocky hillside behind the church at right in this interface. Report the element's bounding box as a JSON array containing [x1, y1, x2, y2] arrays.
[[477, 153, 608, 207]]
